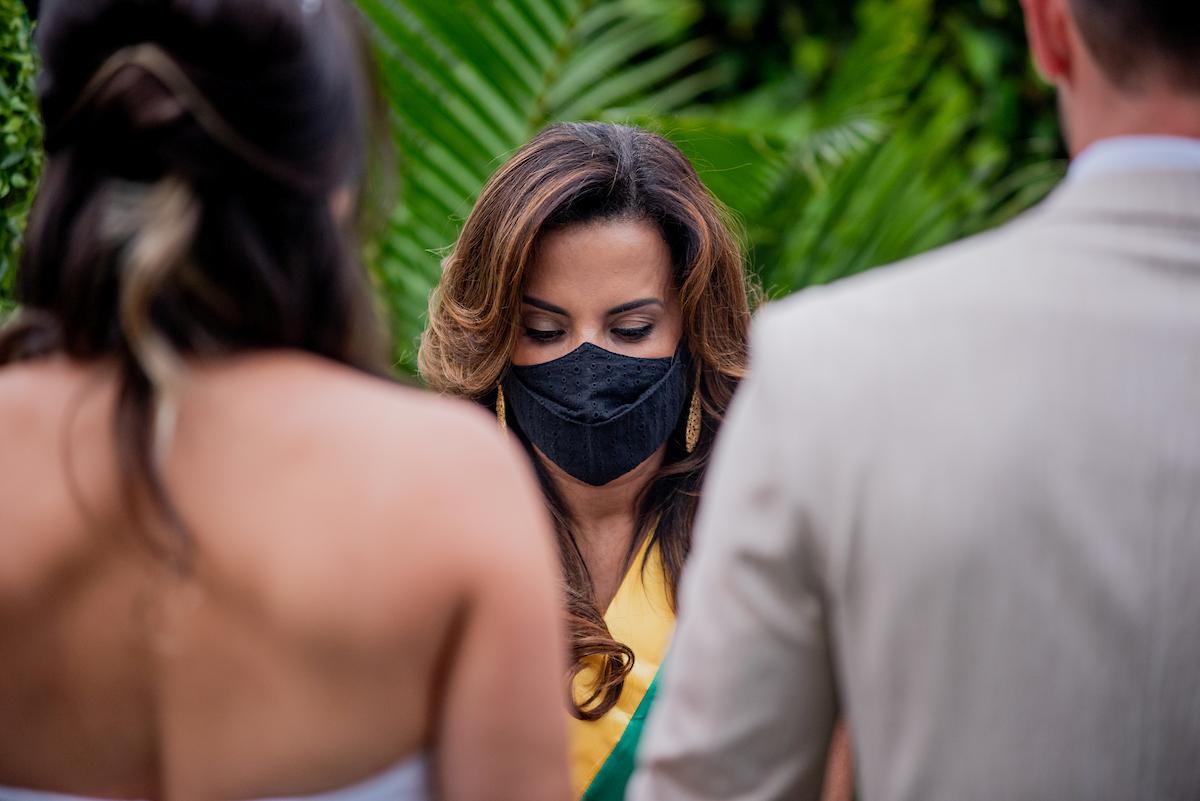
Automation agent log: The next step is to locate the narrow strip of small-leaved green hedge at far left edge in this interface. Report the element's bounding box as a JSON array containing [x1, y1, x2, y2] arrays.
[[0, 0, 42, 315]]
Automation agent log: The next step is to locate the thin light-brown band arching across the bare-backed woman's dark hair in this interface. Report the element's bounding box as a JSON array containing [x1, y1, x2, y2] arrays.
[[64, 43, 320, 194]]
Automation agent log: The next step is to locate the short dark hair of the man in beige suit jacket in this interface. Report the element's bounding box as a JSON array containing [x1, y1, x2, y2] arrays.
[[1072, 0, 1200, 92]]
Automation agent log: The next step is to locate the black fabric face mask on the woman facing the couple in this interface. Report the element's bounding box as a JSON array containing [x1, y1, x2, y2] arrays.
[[504, 342, 688, 487]]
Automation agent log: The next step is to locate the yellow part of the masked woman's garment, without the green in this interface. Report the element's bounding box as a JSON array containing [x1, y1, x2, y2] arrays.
[[570, 537, 674, 799]]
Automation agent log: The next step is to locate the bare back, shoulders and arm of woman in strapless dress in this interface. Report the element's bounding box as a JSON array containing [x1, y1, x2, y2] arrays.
[[0, 354, 565, 799]]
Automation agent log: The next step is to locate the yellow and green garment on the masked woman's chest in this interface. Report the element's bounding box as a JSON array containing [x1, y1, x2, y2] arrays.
[[570, 537, 674, 801]]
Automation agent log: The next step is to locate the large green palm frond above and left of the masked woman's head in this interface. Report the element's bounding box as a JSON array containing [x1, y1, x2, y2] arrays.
[[359, 0, 720, 367]]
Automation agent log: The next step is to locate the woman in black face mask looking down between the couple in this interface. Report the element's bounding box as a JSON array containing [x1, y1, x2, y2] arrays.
[[420, 124, 782, 800]]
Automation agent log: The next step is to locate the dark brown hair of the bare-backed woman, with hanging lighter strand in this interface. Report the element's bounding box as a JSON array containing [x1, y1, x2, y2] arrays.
[[0, 0, 385, 556]]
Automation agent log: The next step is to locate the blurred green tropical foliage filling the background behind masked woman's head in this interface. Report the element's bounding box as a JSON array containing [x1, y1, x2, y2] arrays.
[[359, 0, 1061, 366]]
